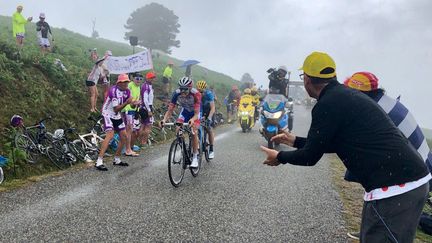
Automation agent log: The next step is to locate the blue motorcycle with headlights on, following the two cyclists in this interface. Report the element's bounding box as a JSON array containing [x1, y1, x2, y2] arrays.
[[260, 94, 292, 149]]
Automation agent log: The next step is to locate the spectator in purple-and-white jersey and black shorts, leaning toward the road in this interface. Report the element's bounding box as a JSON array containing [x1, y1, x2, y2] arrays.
[[96, 74, 139, 171]]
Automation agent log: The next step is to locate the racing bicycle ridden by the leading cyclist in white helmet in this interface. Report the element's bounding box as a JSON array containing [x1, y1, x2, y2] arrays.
[[165, 123, 202, 187]]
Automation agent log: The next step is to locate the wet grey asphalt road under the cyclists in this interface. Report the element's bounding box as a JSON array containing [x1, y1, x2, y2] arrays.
[[0, 107, 347, 242]]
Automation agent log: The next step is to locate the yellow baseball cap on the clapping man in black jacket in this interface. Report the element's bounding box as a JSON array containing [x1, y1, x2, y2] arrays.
[[299, 51, 336, 78]]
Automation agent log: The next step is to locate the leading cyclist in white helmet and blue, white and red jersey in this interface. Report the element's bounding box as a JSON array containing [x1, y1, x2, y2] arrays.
[[160, 77, 201, 168]]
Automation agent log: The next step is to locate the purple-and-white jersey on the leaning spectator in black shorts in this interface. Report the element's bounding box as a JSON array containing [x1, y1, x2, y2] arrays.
[[102, 85, 130, 120]]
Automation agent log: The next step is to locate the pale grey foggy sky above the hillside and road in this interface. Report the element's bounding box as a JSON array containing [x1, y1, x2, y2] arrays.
[[0, 0, 432, 128]]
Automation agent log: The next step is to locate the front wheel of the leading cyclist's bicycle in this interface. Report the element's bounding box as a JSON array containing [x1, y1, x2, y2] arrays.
[[168, 139, 186, 187]]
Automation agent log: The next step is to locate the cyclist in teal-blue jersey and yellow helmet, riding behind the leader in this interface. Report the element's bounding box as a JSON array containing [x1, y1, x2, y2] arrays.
[[197, 80, 216, 159]]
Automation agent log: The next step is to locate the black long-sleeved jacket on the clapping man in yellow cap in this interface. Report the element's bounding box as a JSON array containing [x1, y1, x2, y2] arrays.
[[277, 81, 429, 192]]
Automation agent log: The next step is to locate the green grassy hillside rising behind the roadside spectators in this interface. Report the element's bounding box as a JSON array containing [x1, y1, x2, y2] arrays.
[[0, 16, 237, 180]]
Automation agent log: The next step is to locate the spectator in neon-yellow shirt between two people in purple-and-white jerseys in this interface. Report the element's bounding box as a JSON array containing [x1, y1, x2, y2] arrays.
[[123, 73, 143, 156]]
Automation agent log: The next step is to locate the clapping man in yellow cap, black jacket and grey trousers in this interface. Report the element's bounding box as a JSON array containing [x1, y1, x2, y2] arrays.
[[262, 52, 431, 242]]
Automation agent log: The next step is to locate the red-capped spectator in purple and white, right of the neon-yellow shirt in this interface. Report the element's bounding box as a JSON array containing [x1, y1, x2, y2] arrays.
[[139, 72, 156, 145]]
